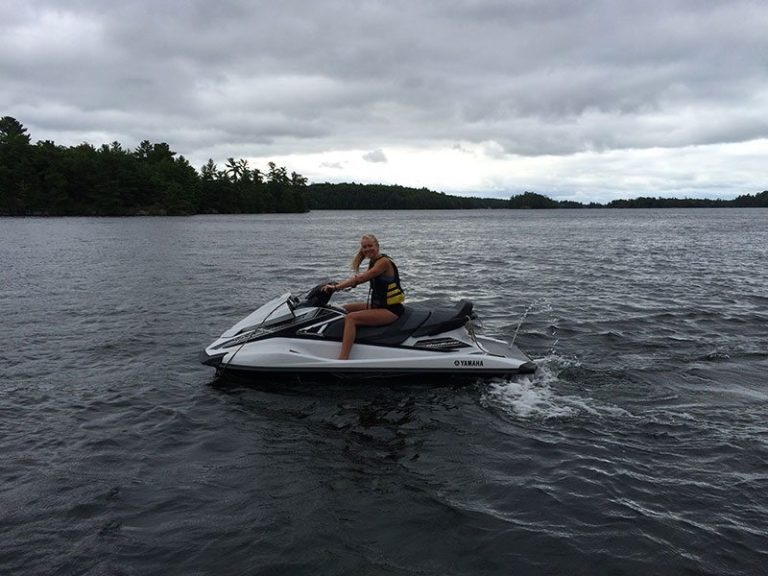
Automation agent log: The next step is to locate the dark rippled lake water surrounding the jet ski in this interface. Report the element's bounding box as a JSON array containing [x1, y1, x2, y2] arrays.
[[0, 209, 768, 576]]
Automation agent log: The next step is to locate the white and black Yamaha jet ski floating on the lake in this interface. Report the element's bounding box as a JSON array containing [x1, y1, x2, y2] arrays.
[[200, 284, 536, 378]]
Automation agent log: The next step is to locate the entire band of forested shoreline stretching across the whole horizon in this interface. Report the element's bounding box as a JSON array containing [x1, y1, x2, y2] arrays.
[[0, 116, 768, 216]]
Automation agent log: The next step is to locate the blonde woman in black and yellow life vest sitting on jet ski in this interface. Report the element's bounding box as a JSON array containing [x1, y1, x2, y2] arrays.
[[323, 234, 405, 360]]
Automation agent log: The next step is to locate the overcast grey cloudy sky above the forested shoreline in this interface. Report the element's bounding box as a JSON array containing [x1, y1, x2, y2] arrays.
[[0, 0, 768, 202]]
